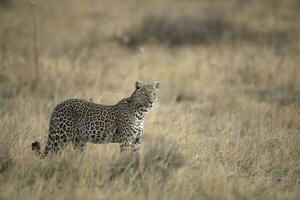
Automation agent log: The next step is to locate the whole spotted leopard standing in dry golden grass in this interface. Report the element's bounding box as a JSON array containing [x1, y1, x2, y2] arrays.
[[31, 81, 159, 158]]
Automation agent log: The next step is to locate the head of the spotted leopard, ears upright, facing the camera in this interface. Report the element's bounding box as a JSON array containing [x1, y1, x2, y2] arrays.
[[130, 81, 159, 109]]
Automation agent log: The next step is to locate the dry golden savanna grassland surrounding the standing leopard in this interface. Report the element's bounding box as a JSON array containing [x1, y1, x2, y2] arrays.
[[0, 0, 300, 199]]
